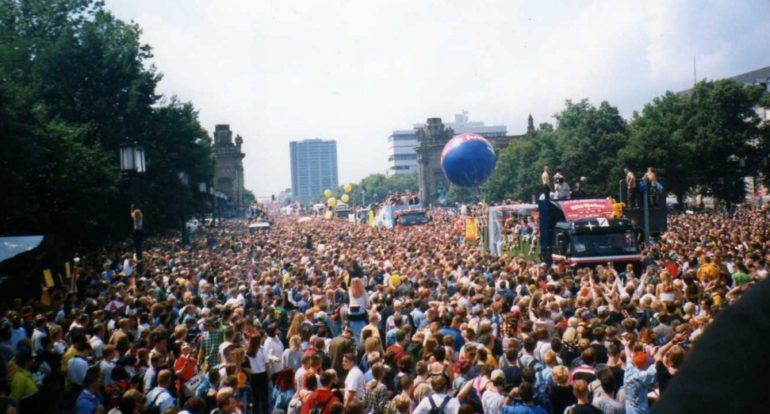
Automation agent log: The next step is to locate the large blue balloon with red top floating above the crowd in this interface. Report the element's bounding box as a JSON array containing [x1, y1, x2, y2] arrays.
[[441, 134, 497, 187]]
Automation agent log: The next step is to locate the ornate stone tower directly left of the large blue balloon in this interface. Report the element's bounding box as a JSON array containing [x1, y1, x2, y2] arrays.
[[415, 118, 454, 207]]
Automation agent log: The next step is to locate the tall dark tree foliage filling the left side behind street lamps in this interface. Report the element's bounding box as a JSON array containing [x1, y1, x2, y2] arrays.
[[0, 0, 213, 242]]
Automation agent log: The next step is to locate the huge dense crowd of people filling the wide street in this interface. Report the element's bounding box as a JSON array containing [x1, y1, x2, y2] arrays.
[[0, 200, 770, 414]]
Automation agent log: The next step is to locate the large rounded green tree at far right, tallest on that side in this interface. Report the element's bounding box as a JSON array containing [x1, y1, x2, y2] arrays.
[[620, 79, 764, 202]]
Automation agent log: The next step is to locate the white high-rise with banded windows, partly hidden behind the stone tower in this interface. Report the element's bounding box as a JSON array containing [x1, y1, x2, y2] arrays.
[[388, 111, 509, 174]]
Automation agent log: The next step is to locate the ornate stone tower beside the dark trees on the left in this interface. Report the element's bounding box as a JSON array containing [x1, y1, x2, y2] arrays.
[[214, 125, 245, 215]]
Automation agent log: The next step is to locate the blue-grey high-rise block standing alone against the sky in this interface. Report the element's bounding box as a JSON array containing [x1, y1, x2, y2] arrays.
[[289, 139, 339, 203]]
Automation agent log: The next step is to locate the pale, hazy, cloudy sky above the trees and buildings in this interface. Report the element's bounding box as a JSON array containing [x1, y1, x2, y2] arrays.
[[106, 0, 770, 197]]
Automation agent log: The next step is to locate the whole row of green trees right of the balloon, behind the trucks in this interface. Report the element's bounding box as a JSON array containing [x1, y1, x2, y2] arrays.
[[482, 84, 770, 202]]
